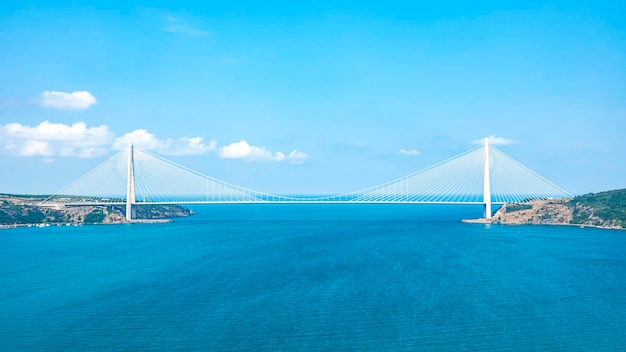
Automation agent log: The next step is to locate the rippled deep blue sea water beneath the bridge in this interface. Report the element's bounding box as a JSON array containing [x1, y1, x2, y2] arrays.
[[0, 204, 626, 351]]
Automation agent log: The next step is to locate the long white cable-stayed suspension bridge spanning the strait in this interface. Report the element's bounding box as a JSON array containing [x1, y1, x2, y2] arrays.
[[42, 138, 572, 221]]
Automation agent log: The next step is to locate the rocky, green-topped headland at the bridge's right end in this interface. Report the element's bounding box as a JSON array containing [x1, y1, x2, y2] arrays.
[[487, 189, 626, 229]]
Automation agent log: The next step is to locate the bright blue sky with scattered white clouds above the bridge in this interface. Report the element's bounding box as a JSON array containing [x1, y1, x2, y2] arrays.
[[0, 1, 626, 193]]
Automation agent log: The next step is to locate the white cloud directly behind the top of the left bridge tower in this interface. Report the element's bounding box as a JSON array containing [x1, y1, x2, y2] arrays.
[[113, 129, 217, 155]]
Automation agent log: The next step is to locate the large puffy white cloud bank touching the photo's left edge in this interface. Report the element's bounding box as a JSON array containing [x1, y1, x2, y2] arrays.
[[0, 121, 113, 158]]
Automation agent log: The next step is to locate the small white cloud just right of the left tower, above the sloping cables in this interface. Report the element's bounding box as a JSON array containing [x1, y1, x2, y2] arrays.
[[219, 140, 308, 163]]
